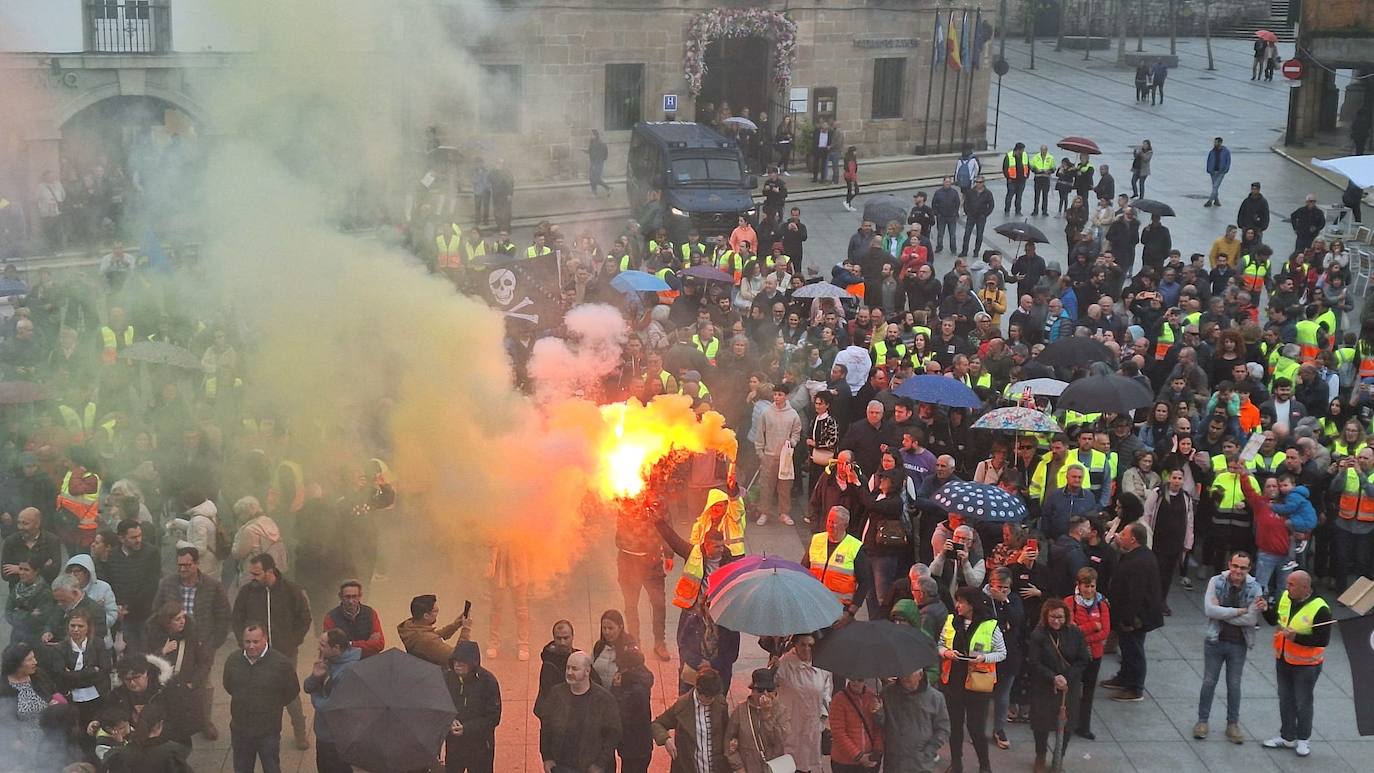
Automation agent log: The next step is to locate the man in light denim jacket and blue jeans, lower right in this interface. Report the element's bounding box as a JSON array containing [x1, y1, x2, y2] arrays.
[[1193, 551, 1268, 744]]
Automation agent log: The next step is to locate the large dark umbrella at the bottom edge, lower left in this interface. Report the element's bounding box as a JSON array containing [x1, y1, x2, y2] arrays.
[[323, 649, 456, 772]]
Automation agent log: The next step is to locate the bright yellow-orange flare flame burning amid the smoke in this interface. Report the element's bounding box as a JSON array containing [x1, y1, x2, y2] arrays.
[[595, 394, 738, 500]]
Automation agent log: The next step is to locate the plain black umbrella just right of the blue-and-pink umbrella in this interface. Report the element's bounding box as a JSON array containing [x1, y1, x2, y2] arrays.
[[812, 621, 940, 680]]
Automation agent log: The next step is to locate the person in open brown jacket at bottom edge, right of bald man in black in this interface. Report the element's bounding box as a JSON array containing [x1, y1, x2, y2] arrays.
[[649, 669, 730, 773]]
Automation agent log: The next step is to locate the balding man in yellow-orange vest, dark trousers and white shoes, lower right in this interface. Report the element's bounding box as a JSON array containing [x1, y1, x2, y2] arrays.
[[1264, 570, 1336, 757]]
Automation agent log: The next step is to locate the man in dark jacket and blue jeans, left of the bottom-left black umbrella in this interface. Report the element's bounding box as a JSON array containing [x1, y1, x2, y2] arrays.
[[224, 623, 301, 773]]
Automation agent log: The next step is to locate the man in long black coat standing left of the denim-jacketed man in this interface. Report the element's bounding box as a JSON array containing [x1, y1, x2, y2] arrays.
[[1102, 522, 1164, 703]]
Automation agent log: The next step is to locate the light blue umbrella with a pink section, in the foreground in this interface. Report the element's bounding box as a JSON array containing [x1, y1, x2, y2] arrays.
[[710, 568, 842, 636]]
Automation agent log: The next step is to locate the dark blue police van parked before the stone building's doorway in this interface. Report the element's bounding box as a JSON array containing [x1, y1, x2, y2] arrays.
[[625, 121, 758, 244]]
